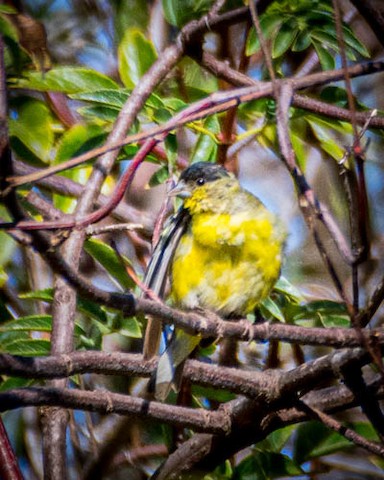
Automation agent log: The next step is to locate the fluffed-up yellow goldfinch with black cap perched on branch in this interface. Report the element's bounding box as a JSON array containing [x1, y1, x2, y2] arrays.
[[144, 162, 285, 400]]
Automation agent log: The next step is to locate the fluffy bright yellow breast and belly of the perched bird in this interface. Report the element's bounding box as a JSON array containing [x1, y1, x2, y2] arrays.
[[171, 178, 284, 316]]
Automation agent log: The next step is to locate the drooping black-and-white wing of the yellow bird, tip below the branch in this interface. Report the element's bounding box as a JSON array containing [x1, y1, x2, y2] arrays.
[[143, 207, 190, 359]]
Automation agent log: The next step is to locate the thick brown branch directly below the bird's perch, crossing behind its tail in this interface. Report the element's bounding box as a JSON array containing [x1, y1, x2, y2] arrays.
[[0, 344, 384, 400]]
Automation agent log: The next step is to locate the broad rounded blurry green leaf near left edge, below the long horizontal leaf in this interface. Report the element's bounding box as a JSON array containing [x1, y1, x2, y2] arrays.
[[9, 99, 54, 163]]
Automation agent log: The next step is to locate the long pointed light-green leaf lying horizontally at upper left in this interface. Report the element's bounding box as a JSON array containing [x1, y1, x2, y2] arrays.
[[13, 67, 118, 93]]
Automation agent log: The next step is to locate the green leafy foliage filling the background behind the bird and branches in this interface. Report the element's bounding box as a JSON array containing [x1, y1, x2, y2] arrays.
[[0, 0, 384, 480]]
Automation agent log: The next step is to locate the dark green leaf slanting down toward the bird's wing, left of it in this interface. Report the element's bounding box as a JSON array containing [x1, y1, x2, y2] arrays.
[[84, 239, 135, 290]]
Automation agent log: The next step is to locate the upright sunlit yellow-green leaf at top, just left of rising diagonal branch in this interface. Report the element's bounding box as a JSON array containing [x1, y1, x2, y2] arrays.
[[118, 27, 157, 88]]
